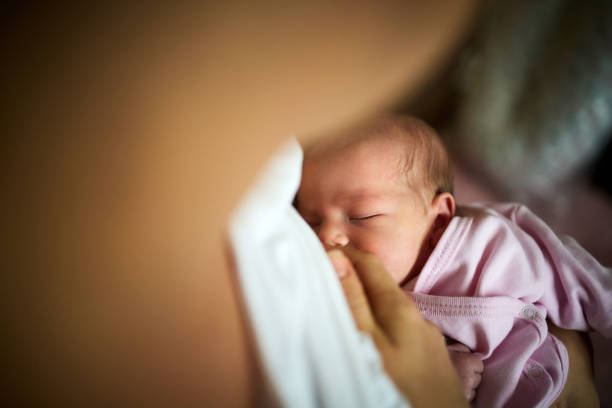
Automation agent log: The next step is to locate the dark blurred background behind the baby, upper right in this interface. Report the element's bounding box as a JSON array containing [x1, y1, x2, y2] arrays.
[[396, 0, 612, 406]]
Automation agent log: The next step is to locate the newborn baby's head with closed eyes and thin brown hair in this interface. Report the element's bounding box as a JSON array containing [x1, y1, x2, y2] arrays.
[[297, 116, 455, 283]]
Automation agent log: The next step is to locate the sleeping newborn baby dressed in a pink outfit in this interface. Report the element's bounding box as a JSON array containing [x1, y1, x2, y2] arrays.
[[296, 113, 612, 407]]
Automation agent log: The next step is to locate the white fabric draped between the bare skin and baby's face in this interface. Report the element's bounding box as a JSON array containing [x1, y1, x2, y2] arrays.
[[230, 140, 409, 407]]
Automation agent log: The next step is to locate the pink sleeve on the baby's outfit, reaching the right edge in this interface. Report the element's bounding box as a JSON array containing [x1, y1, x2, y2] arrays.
[[490, 204, 612, 338]]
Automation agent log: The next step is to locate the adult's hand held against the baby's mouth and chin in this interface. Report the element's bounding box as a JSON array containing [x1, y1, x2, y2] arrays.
[[328, 247, 468, 407]]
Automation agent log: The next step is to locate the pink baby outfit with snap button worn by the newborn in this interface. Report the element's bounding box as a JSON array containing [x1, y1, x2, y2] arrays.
[[405, 204, 612, 407]]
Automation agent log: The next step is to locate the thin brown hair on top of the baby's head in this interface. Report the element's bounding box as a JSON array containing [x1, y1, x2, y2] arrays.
[[307, 115, 453, 201]]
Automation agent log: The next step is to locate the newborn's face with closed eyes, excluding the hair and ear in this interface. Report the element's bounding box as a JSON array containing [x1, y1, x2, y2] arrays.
[[297, 144, 432, 283]]
